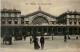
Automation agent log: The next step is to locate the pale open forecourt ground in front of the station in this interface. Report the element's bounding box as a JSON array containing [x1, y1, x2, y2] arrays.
[[0, 36, 80, 52]]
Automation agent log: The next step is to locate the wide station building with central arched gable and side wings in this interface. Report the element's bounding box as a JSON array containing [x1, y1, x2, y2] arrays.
[[1, 8, 80, 36]]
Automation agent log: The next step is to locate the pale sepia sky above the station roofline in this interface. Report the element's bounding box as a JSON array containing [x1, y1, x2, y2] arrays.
[[1, 0, 80, 16]]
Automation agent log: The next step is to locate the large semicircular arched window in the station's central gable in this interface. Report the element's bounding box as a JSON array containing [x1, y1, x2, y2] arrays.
[[32, 16, 48, 25]]
